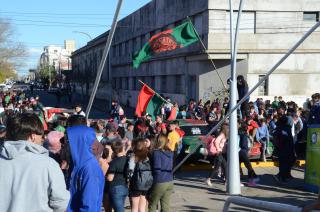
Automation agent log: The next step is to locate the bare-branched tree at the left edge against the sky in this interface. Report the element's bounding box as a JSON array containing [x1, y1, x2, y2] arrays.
[[0, 18, 27, 82]]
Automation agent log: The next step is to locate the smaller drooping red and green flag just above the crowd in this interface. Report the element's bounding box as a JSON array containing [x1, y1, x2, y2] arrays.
[[136, 85, 165, 120]]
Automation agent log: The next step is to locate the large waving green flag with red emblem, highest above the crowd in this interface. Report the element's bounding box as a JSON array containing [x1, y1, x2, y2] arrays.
[[132, 21, 199, 68]]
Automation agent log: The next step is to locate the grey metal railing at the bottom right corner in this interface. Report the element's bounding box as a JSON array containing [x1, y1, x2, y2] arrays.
[[223, 197, 301, 212]]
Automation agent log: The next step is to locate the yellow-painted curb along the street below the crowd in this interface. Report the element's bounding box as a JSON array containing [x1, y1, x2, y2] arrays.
[[181, 160, 306, 171]]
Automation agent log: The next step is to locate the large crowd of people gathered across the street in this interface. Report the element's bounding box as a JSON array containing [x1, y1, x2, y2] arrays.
[[0, 77, 320, 212]]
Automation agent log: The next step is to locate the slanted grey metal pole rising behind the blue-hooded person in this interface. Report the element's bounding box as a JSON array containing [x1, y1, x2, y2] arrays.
[[86, 0, 123, 119]]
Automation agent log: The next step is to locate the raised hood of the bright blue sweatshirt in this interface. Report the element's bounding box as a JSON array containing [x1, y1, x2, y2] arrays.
[[67, 125, 96, 168]]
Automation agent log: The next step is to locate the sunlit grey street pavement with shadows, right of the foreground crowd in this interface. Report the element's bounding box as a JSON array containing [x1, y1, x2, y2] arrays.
[[154, 168, 316, 212]]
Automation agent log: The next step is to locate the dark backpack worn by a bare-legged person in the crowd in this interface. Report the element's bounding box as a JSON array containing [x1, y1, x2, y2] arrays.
[[131, 160, 153, 191]]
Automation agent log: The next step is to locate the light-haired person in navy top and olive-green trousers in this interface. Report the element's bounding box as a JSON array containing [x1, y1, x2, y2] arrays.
[[149, 134, 173, 212]]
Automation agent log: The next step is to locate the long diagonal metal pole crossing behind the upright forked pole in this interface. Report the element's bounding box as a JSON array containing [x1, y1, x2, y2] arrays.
[[173, 21, 320, 172]]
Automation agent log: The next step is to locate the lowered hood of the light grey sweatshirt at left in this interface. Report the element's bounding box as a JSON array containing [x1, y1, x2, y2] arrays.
[[0, 141, 49, 160]]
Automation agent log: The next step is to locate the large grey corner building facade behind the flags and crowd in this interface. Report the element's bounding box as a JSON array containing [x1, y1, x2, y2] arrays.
[[72, 0, 320, 107]]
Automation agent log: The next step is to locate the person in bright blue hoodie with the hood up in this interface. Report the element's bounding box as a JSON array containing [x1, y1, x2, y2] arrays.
[[67, 125, 105, 212]]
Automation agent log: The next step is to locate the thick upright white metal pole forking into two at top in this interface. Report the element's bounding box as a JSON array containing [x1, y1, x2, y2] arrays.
[[227, 0, 243, 195]]
